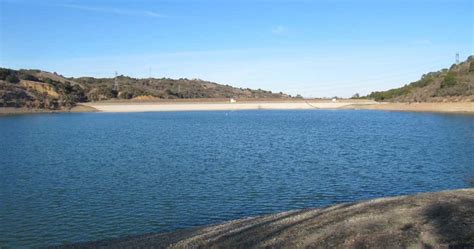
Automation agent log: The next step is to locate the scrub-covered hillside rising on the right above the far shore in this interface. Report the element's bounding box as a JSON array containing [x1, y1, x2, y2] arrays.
[[367, 56, 474, 102]]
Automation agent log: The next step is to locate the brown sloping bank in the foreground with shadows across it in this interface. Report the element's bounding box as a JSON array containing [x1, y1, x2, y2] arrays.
[[53, 188, 474, 248]]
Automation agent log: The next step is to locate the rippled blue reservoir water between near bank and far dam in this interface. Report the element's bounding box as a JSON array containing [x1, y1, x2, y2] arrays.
[[0, 111, 474, 247]]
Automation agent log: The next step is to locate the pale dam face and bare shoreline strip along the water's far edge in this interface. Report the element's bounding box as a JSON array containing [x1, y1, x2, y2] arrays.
[[0, 100, 474, 115]]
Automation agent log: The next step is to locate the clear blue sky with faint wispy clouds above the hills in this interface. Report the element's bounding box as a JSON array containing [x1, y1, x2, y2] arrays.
[[0, 0, 474, 97]]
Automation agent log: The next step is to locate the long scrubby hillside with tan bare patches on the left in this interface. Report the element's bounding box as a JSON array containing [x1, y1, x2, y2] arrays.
[[0, 68, 291, 110]]
